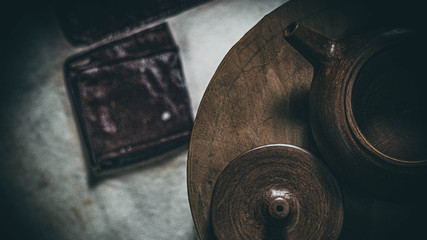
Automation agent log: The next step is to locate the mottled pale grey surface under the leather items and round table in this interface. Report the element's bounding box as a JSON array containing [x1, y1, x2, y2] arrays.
[[0, 0, 285, 240]]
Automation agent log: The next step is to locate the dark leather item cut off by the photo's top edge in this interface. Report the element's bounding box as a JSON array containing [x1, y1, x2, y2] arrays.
[[57, 0, 212, 44]]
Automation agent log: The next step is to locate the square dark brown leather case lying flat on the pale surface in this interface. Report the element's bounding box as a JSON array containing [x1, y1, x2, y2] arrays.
[[65, 24, 193, 174]]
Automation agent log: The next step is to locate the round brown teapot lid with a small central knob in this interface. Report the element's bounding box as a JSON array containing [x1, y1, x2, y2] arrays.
[[211, 144, 344, 240]]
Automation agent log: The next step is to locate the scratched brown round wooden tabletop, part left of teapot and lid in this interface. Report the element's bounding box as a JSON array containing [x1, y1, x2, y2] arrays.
[[188, 0, 368, 240]]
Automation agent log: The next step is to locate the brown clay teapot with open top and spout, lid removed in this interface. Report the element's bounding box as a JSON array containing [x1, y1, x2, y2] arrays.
[[284, 22, 427, 200]]
